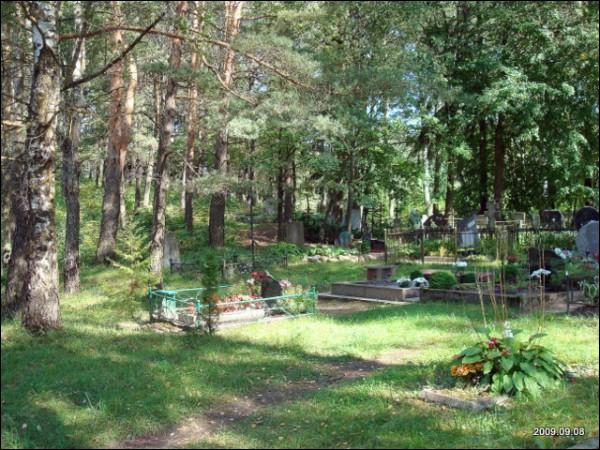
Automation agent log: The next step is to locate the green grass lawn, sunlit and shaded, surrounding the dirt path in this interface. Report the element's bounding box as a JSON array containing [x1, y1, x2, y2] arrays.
[[2, 262, 598, 448]]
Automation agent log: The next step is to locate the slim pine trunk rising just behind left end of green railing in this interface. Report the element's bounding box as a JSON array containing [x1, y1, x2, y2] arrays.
[[150, 1, 187, 275]]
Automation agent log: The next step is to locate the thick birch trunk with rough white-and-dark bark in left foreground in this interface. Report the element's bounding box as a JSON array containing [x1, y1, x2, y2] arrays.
[[22, 2, 61, 331]]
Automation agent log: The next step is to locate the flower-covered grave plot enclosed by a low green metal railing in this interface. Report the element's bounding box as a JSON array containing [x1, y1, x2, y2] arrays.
[[148, 280, 317, 329]]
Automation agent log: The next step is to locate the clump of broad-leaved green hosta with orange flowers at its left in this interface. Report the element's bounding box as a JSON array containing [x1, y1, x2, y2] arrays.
[[451, 323, 565, 397]]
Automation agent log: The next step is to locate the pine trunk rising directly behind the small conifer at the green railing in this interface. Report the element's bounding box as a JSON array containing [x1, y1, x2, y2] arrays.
[[208, 1, 245, 247]]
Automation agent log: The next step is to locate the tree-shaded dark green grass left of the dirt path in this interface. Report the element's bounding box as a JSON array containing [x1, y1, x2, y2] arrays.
[[2, 329, 440, 448]]
